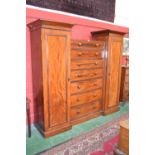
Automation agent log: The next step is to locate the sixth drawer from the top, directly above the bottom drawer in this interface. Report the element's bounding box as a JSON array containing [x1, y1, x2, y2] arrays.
[[71, 89, 102, 106]]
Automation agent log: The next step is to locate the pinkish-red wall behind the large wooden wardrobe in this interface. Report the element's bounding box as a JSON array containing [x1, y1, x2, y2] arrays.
[[26, 8, 128, 123]]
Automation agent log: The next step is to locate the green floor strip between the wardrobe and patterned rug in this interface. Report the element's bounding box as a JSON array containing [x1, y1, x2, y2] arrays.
[[26, 102, 129, 155]]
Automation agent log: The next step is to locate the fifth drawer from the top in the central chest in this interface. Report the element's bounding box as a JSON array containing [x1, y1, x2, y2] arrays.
[[71, 78, 103, 94]]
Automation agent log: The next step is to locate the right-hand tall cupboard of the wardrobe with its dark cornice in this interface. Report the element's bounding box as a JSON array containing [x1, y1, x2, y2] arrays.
[[92, 30, 123, 114]]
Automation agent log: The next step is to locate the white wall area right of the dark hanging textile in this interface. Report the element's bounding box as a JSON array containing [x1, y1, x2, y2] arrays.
[[114, 0, 131, 27]]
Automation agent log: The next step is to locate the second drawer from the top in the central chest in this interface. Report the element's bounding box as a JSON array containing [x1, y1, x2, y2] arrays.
[[71, 50, 102, 59]]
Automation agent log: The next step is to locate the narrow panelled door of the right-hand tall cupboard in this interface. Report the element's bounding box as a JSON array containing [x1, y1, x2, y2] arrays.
[[104, 35, 122, 113]]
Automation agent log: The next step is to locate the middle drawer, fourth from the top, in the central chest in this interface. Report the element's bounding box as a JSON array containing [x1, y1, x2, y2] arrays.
[[71, 69, 103, 81]]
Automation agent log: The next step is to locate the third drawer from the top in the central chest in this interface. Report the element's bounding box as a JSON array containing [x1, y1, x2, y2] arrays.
[[71, 60, 103, 69]]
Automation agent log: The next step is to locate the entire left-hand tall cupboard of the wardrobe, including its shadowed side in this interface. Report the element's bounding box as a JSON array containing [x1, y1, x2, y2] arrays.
[[28, 20, 72, 137]]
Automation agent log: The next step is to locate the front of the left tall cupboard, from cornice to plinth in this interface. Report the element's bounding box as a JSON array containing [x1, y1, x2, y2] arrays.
[[28, 20, 72, 137]]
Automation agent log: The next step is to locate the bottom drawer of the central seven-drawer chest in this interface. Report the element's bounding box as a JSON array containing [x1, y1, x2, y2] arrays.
[[71, 101, 101, 120]]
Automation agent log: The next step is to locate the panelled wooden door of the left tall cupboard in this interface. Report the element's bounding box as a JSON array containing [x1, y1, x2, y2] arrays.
[[43, 29, 70, 136]]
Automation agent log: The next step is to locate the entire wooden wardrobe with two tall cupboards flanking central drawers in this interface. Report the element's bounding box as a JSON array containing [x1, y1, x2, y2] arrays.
[[28, 20, 126, 137]]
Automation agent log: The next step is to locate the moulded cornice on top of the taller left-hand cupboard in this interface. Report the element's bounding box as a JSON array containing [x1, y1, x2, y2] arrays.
[[27, 19, 73, 31]]
